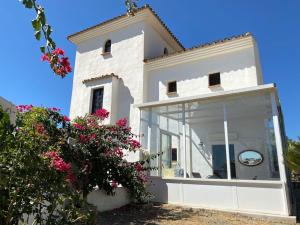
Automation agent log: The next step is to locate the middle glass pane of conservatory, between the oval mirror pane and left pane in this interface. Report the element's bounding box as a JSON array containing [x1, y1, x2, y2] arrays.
[[185, 98, 227, 179]]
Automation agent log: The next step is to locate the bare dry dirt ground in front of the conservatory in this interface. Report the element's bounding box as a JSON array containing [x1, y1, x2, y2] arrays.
[[98, 204, 300, 225]]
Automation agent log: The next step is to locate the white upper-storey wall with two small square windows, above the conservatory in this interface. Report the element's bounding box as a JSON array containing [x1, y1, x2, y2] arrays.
[[145, 48, 260, 102]]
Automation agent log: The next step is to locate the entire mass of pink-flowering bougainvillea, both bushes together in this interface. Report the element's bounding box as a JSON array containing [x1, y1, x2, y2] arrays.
[[0, 105, 157, 225]]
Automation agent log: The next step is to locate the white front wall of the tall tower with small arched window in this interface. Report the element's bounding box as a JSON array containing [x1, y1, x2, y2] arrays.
[[70, 22, 144, 133]]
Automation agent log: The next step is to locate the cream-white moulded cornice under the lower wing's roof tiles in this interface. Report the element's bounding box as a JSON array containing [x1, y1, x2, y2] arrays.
[[144, 36, 254, 71]]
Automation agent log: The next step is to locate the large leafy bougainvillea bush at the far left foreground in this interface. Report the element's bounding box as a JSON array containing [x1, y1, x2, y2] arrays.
[[0, 106, 94, 225]]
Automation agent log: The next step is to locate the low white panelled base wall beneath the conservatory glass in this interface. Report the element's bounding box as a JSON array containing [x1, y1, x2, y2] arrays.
[[149, 177, 288, 216]]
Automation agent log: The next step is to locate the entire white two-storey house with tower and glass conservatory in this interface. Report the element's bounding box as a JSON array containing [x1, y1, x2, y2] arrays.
[[68, 6, 290, 216]]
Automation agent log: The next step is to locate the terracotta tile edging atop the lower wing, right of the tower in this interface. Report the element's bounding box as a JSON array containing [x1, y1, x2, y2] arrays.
[[144, 32, 252, 63]]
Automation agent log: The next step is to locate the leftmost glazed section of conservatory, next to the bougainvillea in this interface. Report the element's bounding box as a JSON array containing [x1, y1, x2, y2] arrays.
[[141, 104, 184, 177]]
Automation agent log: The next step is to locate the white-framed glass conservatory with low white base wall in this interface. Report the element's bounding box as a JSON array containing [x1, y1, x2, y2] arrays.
[[138, 85, 289, 215]]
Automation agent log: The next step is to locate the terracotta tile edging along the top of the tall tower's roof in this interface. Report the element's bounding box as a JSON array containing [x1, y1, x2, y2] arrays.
[[68, 4, 184, 49]]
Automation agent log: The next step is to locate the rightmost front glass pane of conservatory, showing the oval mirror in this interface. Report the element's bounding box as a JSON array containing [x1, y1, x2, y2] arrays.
[[224, 93, 279, 180]]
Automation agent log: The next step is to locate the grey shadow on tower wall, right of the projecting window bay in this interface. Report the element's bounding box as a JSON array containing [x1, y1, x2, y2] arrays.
[[117, 79, 133, 123]]
